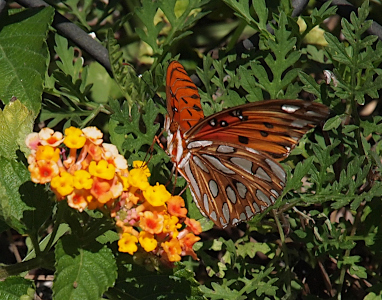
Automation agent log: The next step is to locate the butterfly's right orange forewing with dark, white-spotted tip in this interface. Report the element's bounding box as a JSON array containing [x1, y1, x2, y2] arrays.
[[185, 100, 329, 160]]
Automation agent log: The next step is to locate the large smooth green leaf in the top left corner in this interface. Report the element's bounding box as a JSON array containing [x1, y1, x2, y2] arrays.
[[0, 7, 54, 116]]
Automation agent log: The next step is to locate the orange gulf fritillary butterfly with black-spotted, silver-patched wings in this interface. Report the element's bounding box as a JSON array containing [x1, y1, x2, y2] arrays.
[[165, 61, 329, 228]]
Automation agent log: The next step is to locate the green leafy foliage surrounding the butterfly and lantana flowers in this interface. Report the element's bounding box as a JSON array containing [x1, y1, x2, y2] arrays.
[[0, 0, 382, 299]]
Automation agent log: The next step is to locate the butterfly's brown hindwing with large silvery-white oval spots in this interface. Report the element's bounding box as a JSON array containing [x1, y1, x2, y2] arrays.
[[184, 141, 286, 227]]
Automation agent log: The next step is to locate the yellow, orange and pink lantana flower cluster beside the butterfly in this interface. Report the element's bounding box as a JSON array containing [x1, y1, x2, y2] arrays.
[[26, 127, 202, 263]]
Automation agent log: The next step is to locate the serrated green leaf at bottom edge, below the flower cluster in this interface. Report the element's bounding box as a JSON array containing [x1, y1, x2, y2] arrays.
[[53, 235, 117, 300]]
